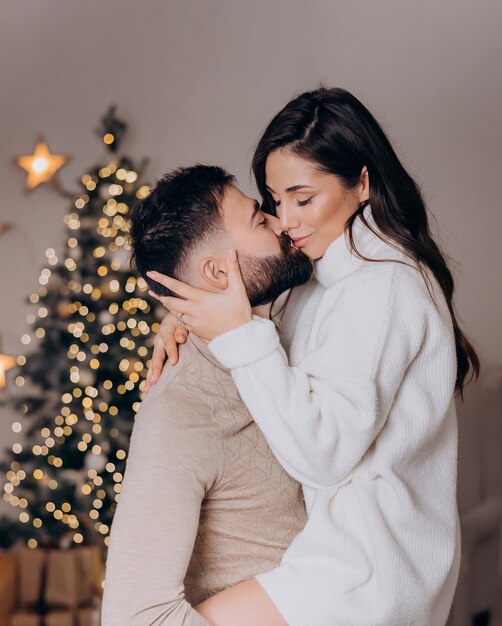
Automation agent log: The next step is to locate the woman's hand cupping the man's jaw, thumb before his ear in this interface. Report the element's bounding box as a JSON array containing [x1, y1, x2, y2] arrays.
[[147, 250, 253, 341]]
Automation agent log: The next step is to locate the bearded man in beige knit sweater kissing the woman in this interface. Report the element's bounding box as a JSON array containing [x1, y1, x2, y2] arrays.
[[102, 165, 312, 626]]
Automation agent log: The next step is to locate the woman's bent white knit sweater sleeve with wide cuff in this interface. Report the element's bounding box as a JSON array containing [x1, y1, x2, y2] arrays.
[[209, 264, 425, 488]]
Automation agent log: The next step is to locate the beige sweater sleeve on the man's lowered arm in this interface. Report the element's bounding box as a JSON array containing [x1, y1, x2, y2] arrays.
[[102, 389, 221, 626]]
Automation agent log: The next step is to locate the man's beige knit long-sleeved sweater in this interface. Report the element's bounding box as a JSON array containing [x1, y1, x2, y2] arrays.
[[102, 335, 306, 626]]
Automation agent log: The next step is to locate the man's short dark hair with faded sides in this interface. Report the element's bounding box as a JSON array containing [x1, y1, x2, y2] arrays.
[[129, 165, 235, 296]]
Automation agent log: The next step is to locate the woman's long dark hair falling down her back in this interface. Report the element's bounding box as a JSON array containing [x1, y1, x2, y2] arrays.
[[253, 87, 480, 396]]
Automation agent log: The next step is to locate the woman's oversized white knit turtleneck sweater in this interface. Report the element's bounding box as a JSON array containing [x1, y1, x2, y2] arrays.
[[209, 207, 460, 626]]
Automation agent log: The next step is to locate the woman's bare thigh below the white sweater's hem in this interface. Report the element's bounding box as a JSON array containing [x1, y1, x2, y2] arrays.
[[195, 578, 288, 626]]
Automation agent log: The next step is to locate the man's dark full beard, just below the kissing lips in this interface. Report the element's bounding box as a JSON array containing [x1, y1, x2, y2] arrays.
[[239, 235, 313, 306]]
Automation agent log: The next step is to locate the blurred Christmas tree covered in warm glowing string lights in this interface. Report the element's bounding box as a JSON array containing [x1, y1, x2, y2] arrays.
[[0, 107, 158, 548]]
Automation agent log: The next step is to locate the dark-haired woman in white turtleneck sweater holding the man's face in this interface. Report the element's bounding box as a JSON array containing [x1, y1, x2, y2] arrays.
[[144, 88, 479, 626]]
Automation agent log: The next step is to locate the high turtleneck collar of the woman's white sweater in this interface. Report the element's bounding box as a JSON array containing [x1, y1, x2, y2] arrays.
[[314, 205, 386, 289]]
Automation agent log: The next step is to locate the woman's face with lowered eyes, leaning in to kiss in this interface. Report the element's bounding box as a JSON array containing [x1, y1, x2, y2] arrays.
[[265, 148, 369, 260]]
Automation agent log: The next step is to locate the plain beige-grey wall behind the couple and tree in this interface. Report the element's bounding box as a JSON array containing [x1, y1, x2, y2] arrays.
[[0, 0, 502, 478]]
